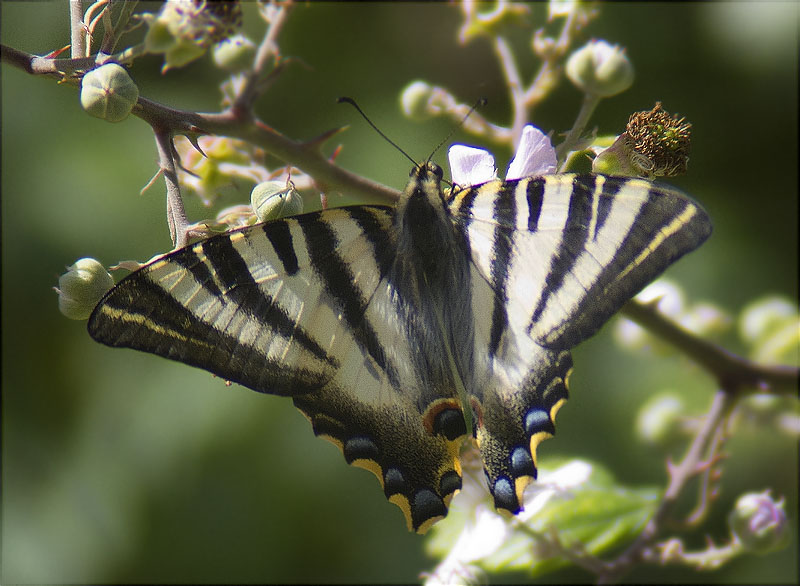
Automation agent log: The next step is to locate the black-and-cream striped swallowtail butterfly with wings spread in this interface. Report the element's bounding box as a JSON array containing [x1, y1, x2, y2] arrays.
[[88, 162, 711, 533]]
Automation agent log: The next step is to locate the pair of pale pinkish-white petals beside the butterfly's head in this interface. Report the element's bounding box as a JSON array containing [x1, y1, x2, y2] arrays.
[[447, 124, 556, 185]]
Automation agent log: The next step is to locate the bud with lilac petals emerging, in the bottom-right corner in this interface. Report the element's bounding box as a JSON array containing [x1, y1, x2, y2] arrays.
[[728, 490, 789, 554]]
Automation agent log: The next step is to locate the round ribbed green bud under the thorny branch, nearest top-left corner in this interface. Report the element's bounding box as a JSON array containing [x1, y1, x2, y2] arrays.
[[81, 63, 139, 122]]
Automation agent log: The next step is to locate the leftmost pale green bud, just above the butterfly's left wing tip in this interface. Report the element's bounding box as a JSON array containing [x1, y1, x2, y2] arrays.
[[56, 258, 114, 320]]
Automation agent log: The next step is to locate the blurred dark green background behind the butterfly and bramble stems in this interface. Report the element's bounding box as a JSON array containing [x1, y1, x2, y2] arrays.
[[1, 2, 798, 583]]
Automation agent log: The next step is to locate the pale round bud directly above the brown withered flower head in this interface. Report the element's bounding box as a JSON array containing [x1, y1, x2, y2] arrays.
[[566, 41, 633, 98]]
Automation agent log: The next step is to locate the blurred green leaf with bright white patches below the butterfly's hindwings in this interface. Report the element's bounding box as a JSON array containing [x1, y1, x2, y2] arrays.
[[428, 460, 660, 577]]
